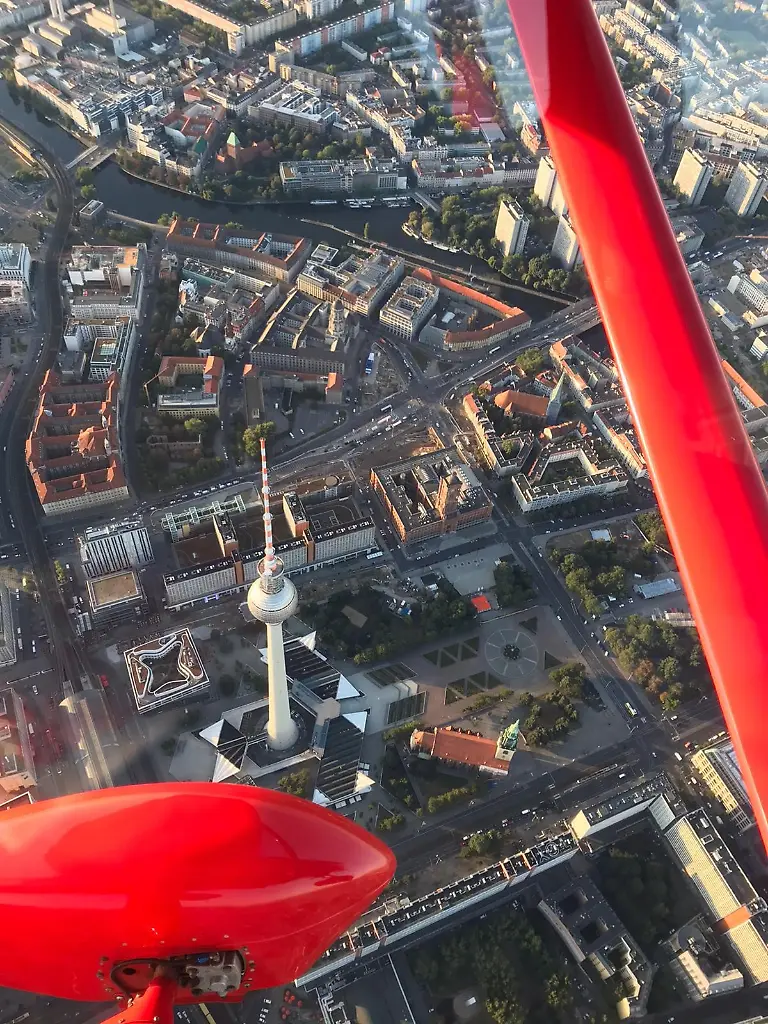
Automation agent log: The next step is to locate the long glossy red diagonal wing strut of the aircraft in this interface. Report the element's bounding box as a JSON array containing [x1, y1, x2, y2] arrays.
[[509, 0, 768, 843]]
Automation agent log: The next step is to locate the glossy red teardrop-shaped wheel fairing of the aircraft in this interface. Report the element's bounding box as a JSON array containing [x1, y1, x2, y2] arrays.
[[0, 782, 394, 1002]]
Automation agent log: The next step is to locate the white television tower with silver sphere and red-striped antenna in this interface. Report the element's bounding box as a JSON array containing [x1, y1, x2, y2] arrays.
[[248, 437, 299, 751]]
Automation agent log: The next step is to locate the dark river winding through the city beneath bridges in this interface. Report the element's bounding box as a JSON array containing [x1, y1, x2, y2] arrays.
[[0, 80, 562, 319]]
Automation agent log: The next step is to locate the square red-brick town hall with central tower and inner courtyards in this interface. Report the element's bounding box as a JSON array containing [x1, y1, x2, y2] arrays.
[[371, 449, 494, 544]]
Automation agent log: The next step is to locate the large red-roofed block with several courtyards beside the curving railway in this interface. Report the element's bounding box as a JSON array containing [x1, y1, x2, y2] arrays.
[[26, 370, 128, 515]]
